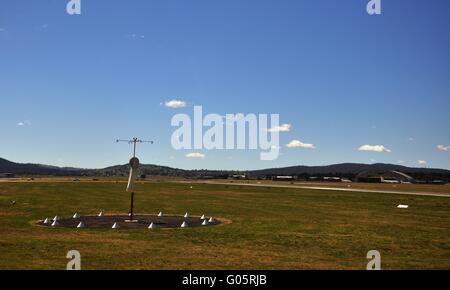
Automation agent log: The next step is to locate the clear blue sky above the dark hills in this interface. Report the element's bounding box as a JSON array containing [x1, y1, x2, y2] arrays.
[[0, 0, 450, 169]]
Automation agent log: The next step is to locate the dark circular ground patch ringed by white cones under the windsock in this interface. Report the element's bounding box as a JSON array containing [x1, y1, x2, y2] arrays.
[[38, 215, 221, 229]]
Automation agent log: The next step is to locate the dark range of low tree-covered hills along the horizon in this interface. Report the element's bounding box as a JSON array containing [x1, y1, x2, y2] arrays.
[[0, 158, 450, 180]]
